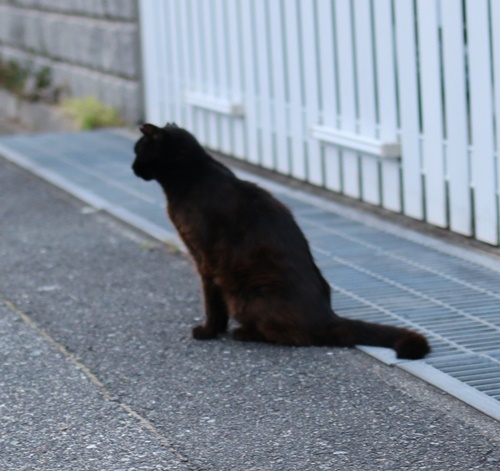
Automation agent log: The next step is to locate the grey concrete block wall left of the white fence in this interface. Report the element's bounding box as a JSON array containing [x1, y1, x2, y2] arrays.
[[0, 0, 143, 123]]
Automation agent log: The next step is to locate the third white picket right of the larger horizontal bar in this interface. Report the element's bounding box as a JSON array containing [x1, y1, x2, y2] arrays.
[[441, 0, 472, 235]]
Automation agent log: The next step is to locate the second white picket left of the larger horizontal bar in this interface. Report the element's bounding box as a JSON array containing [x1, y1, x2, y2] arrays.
[[269, 0, 290, 174]]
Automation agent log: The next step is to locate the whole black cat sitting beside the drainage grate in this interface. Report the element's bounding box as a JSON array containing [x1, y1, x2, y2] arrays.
[[132, 124, 430, 359]]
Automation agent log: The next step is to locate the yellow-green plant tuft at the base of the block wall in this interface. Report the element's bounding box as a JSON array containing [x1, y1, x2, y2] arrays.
[[62, 97, 124, 129]]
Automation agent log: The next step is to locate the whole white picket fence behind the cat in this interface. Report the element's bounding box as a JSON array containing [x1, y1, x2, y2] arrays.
[[140, 0, 500, 245]]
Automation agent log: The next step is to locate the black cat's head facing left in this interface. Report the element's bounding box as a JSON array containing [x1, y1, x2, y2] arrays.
[[132, 123, 192, 181]]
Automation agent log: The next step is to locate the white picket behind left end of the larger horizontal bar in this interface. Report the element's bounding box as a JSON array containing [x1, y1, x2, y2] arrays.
[[300, 0, 323, 185]]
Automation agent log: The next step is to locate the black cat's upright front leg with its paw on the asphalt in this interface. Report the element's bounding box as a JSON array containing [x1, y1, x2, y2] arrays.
[[193, 277, 229, 340]]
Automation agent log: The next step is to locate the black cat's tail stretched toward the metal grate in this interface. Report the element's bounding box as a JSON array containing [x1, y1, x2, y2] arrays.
[[327, 317, 431, 360]]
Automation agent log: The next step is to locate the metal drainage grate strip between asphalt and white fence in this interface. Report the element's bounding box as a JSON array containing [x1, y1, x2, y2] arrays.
[[0, 131, 500, 420]]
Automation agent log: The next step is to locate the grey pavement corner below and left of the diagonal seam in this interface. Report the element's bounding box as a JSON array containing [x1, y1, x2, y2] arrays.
[[0, 299, 189, 471]]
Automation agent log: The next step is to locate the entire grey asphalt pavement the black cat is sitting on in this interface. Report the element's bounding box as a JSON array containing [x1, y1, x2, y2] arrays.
[[0, 147, 500, 471]]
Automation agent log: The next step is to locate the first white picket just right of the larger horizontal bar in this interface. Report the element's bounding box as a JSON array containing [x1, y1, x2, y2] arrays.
[[394, 0, 424, 219]]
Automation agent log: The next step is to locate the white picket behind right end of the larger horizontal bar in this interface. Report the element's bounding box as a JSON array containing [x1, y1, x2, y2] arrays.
[[373, 0, 401, 212]]
